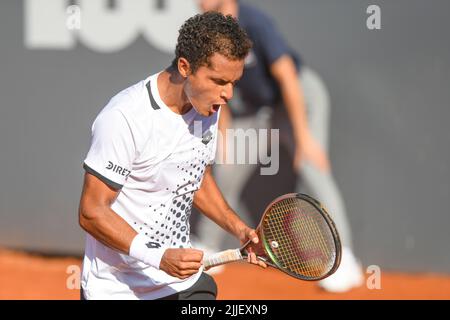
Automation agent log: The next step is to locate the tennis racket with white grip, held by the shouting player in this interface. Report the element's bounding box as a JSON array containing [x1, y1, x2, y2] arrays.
[[203, 193, 341, 281]]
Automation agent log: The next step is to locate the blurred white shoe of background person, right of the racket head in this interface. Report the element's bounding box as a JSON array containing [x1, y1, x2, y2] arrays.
[[319, 247, 364, 292]]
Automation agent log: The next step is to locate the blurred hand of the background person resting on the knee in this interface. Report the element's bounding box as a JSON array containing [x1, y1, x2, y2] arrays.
[[294, 134, 330, 173]]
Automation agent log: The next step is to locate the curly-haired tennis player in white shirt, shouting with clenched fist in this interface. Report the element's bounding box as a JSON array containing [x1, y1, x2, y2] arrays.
[[79, 13, 266, 299]]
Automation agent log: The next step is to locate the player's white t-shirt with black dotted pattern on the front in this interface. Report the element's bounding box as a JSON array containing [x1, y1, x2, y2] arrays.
[[81, 73, 219, 299]]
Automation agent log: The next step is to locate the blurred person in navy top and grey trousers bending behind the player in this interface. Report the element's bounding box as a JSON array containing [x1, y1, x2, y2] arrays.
[[197, 0, 363, 292]]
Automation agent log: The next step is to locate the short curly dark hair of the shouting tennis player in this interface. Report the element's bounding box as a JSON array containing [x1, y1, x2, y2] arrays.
[[172, 12, 252, 73]]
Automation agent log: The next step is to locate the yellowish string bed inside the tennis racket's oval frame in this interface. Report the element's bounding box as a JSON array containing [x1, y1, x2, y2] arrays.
[[263, 198, 336, 279]]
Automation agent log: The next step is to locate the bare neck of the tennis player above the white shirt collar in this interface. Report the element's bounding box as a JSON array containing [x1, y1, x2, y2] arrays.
[[158, 67, 192, 114]]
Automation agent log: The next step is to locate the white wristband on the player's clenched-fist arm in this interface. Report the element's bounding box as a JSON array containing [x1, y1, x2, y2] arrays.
[[130, 233, 166, 270]]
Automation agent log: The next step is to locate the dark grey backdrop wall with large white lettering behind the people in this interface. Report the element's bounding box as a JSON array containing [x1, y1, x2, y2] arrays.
[[0, 0, 450, 272]]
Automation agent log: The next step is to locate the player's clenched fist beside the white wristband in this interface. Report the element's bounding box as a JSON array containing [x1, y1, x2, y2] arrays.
[[159, 248, 203, 279]]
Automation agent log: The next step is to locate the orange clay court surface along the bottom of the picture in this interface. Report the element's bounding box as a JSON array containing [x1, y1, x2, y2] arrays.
[[0, 249, 450, 300]]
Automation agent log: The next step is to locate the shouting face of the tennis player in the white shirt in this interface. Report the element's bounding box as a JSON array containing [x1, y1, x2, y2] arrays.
[[185, 53, 244, 116]]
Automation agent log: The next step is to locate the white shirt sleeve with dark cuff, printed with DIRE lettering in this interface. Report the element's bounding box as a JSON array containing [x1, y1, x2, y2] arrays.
[[83, 110, 136, 189]]
